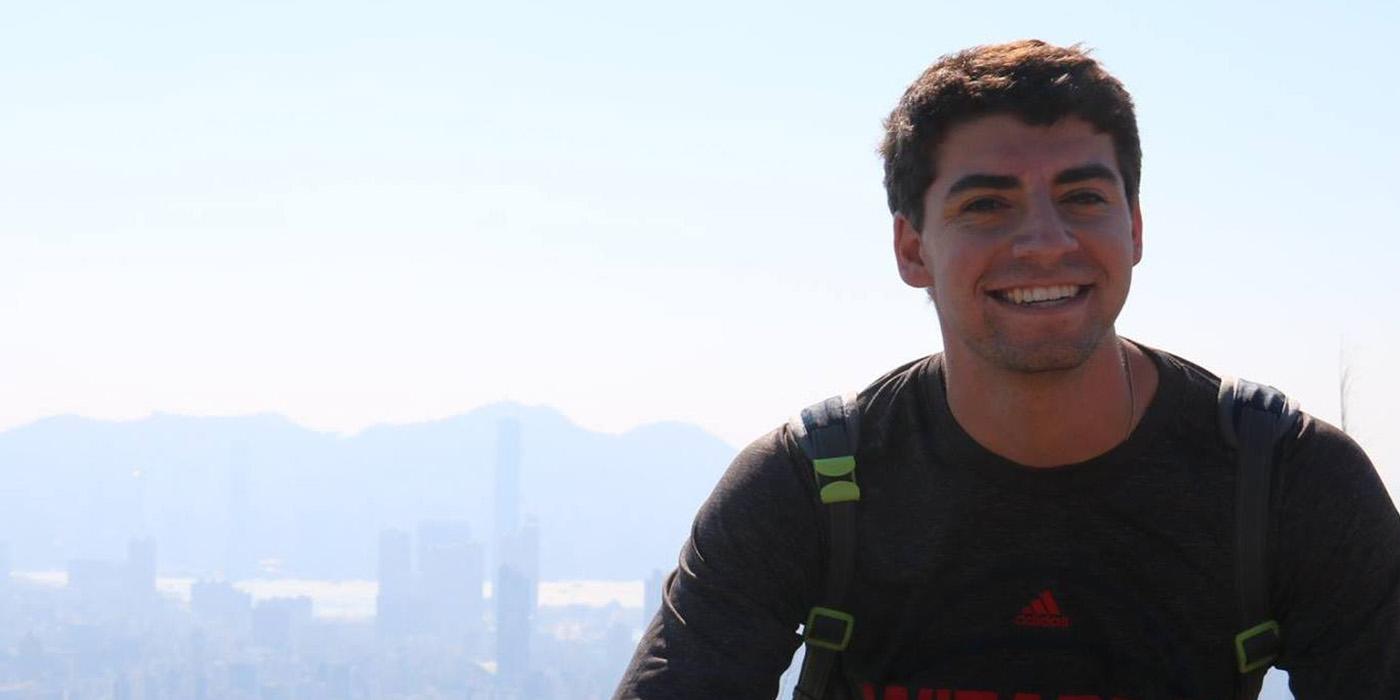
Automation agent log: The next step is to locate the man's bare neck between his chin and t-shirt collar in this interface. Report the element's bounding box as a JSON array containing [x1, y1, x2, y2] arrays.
[[944, 333, 1156, 466]]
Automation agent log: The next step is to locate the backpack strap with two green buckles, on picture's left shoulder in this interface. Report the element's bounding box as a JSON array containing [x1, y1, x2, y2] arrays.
[[788, 396, 861, 700]]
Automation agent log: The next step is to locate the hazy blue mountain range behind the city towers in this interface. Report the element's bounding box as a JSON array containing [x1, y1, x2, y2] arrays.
[[0, 403, 735, 580]]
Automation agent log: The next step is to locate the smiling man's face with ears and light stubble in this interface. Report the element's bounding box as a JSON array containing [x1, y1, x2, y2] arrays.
[[895, 115, 1142, 372]]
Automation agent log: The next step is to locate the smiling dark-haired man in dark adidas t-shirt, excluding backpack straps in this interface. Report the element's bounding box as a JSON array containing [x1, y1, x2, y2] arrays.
[[615, 41, 1400, 700]]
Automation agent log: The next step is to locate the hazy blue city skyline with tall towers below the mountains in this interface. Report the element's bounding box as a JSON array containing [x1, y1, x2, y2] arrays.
[[0, 416, 650, 700]]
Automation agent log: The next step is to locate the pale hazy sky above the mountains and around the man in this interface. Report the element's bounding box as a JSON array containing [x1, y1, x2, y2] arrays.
[[0, 0, 1400, 493]]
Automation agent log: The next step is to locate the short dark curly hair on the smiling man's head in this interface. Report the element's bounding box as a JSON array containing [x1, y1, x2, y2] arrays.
[[879, 39, 1142, 230]]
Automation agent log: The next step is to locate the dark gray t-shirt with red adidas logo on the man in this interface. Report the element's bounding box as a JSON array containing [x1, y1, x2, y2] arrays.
[[615, 347, 1400, 700]]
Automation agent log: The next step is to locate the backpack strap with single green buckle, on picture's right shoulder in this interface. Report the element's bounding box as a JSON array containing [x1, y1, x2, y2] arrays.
[[1219, 377, 1302, 700]]
